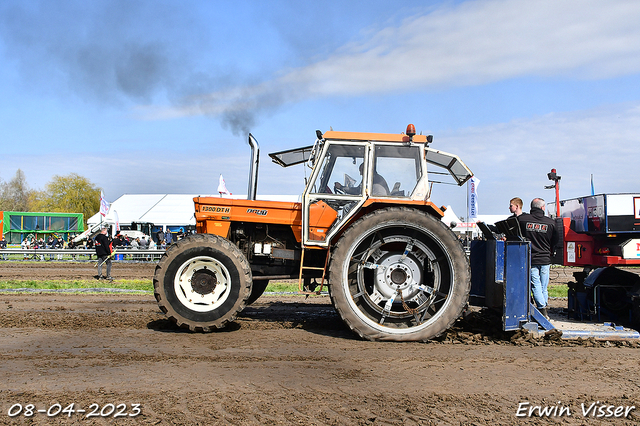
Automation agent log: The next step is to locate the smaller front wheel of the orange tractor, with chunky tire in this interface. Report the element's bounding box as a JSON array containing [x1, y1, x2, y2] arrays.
[[153, 234, 252, 332]]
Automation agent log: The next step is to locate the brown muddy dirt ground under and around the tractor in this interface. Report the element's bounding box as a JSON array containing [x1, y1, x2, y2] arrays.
[[0, 262, 640, 425]]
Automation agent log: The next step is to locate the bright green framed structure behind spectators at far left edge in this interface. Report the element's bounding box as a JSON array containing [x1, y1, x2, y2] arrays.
[[0, 212, 84, 244]]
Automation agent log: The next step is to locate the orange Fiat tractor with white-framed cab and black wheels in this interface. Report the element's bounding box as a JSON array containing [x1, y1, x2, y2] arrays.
[[153, 125, 473, 341]]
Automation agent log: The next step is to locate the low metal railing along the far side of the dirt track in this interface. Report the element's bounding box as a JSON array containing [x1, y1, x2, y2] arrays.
[[0, 247, 165, 262]]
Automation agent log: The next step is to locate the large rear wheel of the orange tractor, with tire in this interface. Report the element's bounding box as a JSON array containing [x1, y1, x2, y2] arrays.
[[329, 207, 471, 341]]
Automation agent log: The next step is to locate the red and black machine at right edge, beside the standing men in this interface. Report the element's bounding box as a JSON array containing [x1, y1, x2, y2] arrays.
[[548, 193, 640, 328]]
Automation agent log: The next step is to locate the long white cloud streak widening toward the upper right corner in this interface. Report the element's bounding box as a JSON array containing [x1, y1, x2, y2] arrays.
[[152, 0, 640, 118]]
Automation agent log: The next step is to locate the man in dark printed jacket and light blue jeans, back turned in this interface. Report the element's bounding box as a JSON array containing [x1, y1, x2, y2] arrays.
[[518, 198, 558, 318]]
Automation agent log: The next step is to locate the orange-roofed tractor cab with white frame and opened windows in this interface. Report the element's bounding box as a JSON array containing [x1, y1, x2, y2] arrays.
[[269, 125, 473, 247]]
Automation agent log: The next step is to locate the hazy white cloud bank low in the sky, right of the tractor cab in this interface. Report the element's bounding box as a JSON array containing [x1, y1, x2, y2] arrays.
[[434, 104, 640, 214]]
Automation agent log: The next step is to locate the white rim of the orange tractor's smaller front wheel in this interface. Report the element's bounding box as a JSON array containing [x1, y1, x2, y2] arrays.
[[173, 256, 231, 312]]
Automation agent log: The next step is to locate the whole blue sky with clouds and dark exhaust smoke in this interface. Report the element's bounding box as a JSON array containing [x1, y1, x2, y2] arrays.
[[0, 0, 640, 216]]
